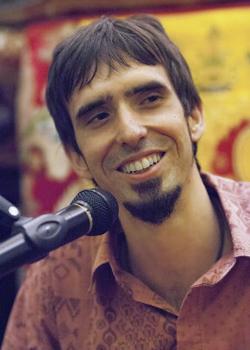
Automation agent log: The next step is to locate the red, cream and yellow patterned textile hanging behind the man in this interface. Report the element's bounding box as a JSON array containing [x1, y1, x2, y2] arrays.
[[18, 7, 250, 215]]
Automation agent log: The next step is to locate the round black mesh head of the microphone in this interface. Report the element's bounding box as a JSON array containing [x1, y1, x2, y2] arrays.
[[71, 188, 118, 236]]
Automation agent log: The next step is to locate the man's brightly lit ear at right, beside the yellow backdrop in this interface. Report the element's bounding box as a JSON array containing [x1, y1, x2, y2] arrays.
[[187, 106, 205, 142]]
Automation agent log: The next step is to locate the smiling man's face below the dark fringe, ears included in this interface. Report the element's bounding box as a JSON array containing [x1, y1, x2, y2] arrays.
[[69, 63, 202, 217]]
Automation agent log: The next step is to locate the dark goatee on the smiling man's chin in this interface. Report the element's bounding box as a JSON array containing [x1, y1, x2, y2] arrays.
[[123, 179, 181, 225]]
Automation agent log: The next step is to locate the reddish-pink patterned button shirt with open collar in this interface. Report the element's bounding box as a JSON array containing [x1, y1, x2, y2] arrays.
[[2, 175, 250, 350]]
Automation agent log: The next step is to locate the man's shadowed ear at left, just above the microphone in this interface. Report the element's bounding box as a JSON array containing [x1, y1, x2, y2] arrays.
[[65, 147, 92, 180]]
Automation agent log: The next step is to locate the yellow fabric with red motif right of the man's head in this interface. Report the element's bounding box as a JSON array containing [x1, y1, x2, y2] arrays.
[[157, 8, 250, 181]]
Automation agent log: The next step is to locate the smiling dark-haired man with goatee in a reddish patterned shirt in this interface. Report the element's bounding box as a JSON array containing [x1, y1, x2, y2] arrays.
[[3, 16, 250, 350]]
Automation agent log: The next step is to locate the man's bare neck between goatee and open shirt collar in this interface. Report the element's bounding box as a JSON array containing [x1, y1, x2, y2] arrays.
[[118, 170, 229, 308]]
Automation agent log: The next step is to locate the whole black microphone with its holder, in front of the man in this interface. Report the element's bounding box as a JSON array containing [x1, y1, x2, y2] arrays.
[[0, 188, 118, 276]]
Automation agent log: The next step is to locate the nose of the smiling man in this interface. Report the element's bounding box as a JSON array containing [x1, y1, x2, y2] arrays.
[[116, 108, 147, 146]]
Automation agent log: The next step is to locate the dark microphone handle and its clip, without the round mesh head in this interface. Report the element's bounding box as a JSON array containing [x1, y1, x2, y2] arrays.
[[0, 196, 84, 278]]
